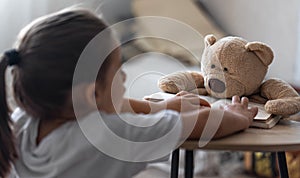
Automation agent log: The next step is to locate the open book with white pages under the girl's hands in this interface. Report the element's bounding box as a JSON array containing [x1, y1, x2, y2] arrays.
[[144, 92, 281, 129]]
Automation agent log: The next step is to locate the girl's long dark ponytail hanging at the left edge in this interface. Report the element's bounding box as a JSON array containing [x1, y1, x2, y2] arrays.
[[0, 55, 17, 178]]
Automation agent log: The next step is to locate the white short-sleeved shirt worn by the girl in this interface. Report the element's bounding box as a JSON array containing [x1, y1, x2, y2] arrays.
[[12, 109, 182, 178]]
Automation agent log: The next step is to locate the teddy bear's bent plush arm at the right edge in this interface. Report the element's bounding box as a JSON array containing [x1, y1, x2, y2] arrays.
[[261, 79, 300, 116]]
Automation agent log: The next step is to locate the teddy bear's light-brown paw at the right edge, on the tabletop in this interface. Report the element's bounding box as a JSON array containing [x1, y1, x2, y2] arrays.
[[265, 97, 300, 116]]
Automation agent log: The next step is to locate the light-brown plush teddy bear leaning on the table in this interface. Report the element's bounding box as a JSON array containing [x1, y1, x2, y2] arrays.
[[158, 34, 300, 116]]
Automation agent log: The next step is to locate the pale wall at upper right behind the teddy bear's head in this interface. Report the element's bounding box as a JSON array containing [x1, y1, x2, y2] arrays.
[[200, 0, 300, 85]]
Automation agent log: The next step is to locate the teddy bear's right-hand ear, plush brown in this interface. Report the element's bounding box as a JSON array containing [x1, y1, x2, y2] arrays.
[[245, 42, 274, 66]]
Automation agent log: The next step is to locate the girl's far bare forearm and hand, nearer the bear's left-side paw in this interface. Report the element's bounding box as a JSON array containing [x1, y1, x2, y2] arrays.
[[122, 92, 210, 114]]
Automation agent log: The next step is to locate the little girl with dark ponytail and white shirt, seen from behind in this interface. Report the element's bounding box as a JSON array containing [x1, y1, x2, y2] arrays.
[[0, 9, 257, 178]]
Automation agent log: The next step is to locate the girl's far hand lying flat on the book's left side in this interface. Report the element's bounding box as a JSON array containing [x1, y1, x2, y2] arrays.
[[162, 91, 210, 112]]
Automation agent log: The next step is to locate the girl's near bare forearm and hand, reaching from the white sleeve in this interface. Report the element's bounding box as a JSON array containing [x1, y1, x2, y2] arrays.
[[181, 96, 258, 139]]
